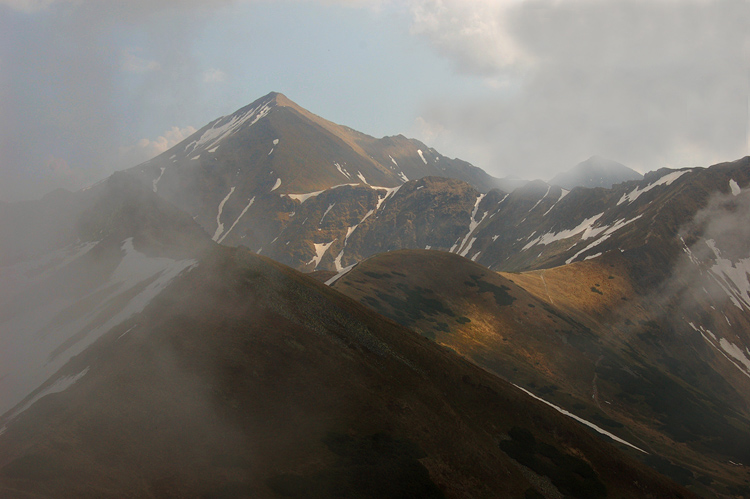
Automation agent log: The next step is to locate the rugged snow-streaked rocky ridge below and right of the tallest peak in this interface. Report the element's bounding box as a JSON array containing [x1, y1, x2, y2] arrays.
[[258, 158, 750, 289]]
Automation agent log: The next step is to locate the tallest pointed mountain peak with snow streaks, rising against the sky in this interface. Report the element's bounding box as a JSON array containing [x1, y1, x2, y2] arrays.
[[130, 93, 506, 250]]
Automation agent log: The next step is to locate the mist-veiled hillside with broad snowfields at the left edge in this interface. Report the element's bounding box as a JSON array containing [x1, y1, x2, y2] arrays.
[[0, 173, 212, 413]]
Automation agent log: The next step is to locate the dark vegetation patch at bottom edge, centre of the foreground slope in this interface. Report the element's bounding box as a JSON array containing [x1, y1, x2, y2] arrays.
[[267, 433, 445, 499]]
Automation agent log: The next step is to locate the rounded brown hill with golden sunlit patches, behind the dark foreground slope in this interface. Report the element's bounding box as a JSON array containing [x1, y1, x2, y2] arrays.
[[332, 250, 750, 495]]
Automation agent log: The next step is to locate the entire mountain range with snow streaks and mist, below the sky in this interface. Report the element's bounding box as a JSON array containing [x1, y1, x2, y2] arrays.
[[0, 93, 750, 497]]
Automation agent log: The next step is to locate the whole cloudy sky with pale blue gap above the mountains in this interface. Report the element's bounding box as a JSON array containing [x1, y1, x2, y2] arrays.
[[0, 0, 750, 201]]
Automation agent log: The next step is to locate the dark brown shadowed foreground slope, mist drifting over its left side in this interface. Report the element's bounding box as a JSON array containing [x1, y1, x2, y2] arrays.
[[0, 247, 691, 498]]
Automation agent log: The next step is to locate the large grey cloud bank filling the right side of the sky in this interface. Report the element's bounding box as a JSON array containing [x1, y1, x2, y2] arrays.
[[406, 0, 750, 178]]
